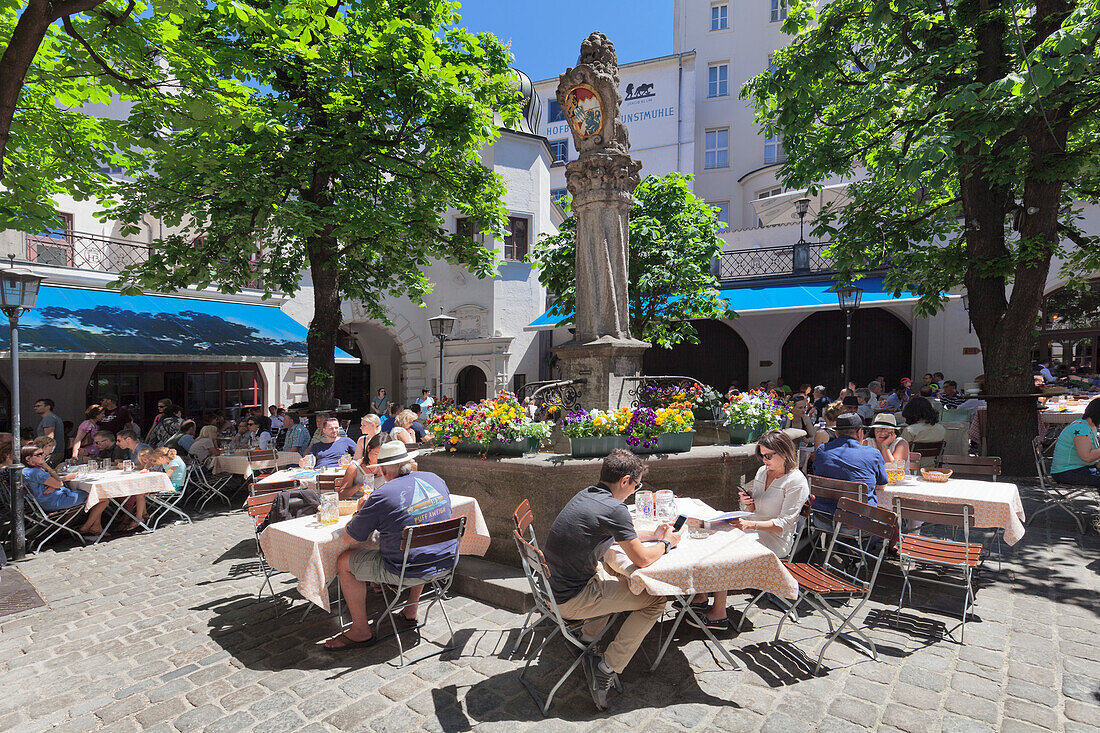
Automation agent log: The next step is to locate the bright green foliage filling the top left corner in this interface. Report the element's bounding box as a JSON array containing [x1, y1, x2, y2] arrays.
[[0, 0, 239, 232]]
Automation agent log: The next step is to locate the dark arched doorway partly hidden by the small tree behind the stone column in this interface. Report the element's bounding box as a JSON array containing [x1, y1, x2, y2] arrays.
[[641, 320, 749, 392]]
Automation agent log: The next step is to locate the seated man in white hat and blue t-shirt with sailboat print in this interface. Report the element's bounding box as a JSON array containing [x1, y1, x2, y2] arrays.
[[325, 440, 454, 652]]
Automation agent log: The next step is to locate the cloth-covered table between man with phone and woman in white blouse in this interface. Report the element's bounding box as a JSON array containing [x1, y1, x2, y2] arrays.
[[604, 500, 799, 671]]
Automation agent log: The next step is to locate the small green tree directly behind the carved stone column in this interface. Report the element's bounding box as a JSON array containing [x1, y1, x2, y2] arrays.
[[529, 173, 732, 348]]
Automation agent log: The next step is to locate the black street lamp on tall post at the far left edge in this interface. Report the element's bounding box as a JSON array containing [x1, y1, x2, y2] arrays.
[[0, 254, 45, 560]]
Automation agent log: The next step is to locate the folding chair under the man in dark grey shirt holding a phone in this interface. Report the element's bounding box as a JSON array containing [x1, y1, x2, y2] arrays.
[[512, 528, 623, 718]]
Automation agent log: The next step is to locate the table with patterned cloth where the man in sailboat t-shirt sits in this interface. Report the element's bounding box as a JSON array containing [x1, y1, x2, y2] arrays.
[[260, 494, 490, 611]]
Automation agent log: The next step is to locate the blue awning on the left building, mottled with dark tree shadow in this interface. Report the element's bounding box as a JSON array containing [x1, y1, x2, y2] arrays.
[[0, 285, 359, 363]]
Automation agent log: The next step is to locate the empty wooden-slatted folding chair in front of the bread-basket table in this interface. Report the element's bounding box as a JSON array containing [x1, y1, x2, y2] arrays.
[[893, 496, 983, 643]]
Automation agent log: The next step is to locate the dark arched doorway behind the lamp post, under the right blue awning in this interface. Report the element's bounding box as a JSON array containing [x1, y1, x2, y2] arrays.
[[782, 308, 913, 394]]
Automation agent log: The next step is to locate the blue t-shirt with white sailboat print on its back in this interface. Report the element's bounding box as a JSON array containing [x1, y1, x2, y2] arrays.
[[344, 471, 454, 578]]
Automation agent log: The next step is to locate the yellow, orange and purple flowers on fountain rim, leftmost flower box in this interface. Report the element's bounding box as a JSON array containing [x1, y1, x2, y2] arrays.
[[427, 392, 553, 450]]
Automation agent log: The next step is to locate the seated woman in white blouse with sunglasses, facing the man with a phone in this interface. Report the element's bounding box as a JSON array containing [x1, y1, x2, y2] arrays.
[[688, 430, 810, 631]]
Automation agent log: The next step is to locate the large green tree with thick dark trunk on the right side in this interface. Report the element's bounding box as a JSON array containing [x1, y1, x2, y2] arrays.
[[741, 0, 1100, 474]]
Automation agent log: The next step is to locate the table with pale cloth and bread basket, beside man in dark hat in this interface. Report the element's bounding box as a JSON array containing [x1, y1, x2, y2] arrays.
[[879, 478, 1024, 545]]
